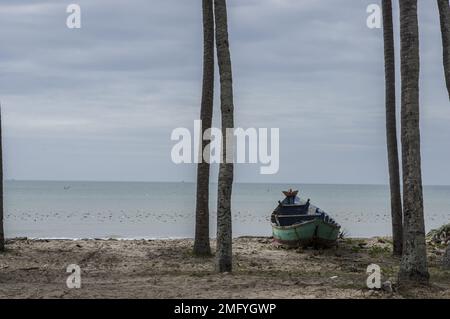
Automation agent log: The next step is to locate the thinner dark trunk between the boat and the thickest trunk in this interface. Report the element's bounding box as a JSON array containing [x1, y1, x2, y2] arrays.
[[383, 0, 403, 256]]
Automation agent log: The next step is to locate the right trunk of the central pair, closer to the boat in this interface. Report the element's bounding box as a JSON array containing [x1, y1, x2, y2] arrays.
[[214, 0, 234, 272]]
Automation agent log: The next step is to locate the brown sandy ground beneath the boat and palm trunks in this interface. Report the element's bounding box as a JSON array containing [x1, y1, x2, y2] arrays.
[[0, 238, 450, 298]]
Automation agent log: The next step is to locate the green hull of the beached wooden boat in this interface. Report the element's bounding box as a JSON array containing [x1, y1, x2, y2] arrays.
[[272, 219, 340, 247]]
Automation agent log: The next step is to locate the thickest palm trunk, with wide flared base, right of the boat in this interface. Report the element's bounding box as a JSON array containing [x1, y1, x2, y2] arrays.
[[399, 0, 429, 285]]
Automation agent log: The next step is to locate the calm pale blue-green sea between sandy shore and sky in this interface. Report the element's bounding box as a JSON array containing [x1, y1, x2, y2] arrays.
[[5, 181, 450, 238]]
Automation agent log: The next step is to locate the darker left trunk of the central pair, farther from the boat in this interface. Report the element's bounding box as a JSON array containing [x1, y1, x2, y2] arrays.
[[194, 0, 214, 256]]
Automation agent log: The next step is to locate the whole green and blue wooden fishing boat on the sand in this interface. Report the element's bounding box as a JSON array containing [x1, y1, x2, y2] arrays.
[[271, 189, 341, 247]]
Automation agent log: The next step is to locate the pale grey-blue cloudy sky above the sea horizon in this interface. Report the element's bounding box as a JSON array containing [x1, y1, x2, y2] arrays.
[[0, 0, 450, 185]]
